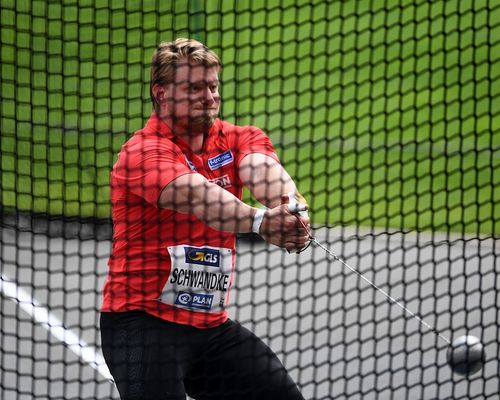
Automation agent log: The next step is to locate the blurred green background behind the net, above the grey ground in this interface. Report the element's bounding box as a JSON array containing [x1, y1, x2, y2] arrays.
[[0, 0, 500, 235]]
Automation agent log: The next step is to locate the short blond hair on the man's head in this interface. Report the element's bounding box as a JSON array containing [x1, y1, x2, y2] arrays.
[[149, 38, 222, 108]]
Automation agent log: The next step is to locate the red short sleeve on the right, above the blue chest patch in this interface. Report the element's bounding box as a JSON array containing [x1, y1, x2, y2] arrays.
[[231, 126, 280, 165]]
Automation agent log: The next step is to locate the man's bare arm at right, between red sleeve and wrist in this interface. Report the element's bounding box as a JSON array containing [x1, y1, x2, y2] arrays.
[[239, 153, 298, 208]]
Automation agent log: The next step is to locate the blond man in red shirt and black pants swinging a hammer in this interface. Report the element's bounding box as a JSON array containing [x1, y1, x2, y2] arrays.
[[101, 39, 309, 400]]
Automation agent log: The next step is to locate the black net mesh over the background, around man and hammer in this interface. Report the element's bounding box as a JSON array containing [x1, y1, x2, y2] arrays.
[[0, 0, 500, 400]]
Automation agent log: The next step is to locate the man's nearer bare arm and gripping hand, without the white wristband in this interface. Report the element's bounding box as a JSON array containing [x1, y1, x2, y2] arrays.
[[158, 173, 308, 251]]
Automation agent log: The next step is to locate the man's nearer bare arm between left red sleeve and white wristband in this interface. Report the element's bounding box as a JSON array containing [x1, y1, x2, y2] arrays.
[[158, 174, 257, 233]]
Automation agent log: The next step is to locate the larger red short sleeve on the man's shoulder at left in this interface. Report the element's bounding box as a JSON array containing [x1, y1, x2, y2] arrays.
[[111, 138, 192, 207]]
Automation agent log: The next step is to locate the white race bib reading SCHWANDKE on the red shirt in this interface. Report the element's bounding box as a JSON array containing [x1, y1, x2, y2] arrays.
[[159, 245, 233, 312]]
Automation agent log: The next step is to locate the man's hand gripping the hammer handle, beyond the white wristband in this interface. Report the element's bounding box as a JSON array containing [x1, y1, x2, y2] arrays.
[[260, 204, 309, 252]]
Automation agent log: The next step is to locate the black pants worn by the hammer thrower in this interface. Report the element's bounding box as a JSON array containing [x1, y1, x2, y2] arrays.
[[101, 311, 303, 400]]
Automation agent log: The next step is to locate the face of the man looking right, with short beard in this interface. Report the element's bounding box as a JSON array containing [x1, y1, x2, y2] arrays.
[[165, 63, 220, 129]]
